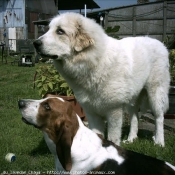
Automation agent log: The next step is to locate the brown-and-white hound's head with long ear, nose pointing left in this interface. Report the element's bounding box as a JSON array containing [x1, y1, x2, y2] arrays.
[[18, 97, 78, 171]]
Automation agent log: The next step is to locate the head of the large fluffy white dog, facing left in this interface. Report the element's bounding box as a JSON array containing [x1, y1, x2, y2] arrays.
[[34, 13, 104, 59]]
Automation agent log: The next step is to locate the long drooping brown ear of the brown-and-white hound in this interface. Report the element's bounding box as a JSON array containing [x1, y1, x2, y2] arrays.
[[56, 104, 78, 171]]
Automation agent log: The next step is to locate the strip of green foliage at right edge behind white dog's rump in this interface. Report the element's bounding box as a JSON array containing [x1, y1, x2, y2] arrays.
[[169, 49, 175, 85]]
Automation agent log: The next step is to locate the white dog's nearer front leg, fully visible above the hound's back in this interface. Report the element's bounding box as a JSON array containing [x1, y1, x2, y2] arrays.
[[107, 108, 123, 145]]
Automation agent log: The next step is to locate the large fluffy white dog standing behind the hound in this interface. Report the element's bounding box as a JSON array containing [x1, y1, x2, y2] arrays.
[[34, 13, 170, 146]]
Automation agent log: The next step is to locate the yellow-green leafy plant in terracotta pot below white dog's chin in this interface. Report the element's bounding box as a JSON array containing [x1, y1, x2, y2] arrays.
[[35, 65, 73, 97]]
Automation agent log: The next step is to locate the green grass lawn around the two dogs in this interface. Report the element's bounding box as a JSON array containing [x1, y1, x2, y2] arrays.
[[0, 57, 175, 174]]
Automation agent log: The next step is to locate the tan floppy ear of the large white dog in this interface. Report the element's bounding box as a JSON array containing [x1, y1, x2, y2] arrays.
[[74, 27, 94, 52]]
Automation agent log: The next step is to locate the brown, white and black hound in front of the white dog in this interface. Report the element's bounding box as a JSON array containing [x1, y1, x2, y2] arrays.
[[18, 97, 175, 175]]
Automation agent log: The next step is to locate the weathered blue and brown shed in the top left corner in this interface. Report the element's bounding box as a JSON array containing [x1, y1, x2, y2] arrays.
[[0, 0, 58, 51]]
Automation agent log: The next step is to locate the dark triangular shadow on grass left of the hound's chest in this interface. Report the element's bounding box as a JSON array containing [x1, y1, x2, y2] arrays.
[[30, 138, 51, 156]]
